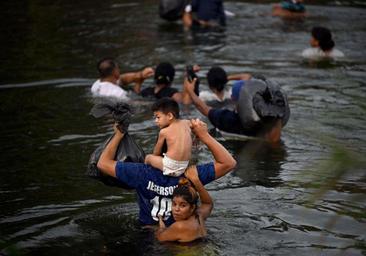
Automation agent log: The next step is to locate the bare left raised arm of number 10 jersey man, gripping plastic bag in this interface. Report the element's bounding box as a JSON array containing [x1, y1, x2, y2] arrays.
[[97, 126, 124, 177]]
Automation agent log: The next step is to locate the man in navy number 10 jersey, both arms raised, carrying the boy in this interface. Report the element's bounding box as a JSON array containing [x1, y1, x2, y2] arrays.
[[98, 119, 236, 225]]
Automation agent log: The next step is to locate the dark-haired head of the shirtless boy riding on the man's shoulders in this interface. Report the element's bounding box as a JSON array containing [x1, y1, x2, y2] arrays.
[[151, 98, 179, 129]]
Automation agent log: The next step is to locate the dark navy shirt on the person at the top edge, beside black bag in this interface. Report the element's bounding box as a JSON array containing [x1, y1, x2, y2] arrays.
[[192, 0, 226, 26]]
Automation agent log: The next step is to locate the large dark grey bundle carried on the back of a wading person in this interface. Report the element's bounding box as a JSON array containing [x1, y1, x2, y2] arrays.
[[238, 79, 290, 131]]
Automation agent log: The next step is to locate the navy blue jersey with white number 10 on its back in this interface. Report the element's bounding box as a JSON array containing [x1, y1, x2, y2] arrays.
[[116, 162, 215, 225]]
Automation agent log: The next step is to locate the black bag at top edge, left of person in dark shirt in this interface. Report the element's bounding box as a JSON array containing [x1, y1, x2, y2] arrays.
[[159, 0, 187, 21]]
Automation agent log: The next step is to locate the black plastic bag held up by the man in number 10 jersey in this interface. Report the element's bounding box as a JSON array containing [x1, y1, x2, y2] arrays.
[[86, 102, 145, 189]]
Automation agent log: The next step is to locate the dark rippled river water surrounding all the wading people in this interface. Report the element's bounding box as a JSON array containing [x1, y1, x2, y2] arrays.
[[0, 0, 366, 255]]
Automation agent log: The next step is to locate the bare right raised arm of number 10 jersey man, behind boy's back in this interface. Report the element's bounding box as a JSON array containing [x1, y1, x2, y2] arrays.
[[191, 119, 236, 179]]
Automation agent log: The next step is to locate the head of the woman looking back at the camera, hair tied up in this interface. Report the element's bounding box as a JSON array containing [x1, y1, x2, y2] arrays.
[[172, 177, 198, 221]]
